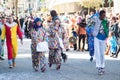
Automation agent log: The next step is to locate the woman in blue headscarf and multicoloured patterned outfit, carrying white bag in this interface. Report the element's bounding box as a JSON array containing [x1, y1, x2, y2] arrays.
[[31, 18, 46, 72]]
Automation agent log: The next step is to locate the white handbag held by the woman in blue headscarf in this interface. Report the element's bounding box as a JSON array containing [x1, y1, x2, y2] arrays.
[[36, 41, 49, 52]]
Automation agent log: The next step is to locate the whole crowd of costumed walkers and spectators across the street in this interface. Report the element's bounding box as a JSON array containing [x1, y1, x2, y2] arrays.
[[0, 10, 120, 74]]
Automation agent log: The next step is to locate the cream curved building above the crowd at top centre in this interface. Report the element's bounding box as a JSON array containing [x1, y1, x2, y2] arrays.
[[46, 0, 81, 14]]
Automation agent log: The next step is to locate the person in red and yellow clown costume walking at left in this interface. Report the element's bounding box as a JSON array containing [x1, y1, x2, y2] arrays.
[[1, 16, 23, 68]]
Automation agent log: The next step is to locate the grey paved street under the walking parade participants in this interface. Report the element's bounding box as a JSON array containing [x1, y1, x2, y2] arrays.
[[0, 39, 120, 80]]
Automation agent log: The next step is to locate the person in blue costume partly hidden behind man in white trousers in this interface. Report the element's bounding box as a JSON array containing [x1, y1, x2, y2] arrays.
[[86, 13, 99, 62]]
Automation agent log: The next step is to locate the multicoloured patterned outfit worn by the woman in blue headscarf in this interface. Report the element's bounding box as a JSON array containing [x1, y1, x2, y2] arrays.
[[31, 28, 47, 69]]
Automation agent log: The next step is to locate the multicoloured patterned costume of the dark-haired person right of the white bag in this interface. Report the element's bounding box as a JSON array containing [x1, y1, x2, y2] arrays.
[[48, 26, 61, 67]]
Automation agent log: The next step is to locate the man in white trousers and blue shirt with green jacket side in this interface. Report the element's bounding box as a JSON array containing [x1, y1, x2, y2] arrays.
[[93, 10, 108, 75]]
